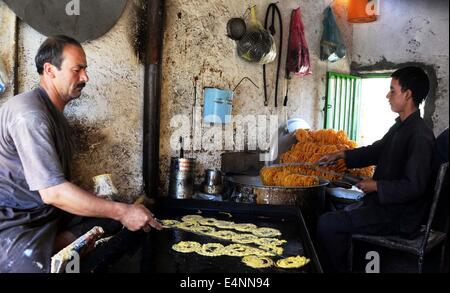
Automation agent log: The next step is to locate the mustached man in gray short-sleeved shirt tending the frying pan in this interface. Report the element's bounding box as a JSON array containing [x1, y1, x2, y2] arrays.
[[0, 36, 161, 272]]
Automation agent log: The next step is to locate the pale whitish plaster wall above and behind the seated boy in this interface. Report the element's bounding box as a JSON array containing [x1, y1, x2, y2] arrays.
[[352, 0, 449, 135]]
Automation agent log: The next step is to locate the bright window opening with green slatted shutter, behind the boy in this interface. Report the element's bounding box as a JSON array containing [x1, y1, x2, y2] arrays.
[[324, 72, 425, 146]]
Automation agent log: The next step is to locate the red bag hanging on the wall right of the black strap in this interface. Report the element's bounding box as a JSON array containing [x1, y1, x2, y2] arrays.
[[286, 7, 311, 76]]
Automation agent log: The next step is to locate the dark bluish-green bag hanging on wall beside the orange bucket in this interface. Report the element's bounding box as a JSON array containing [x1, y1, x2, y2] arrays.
[[320, 6, 347, 62]]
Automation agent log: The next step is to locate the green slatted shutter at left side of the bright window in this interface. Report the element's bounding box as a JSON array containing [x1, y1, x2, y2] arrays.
[[324, 71, 362, 140]]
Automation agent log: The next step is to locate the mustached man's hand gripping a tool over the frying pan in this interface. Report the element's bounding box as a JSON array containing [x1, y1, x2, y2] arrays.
[[120, 204, 162, 232]]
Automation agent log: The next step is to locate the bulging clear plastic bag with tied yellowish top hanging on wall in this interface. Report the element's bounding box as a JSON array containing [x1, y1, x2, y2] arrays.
[[237, 7, 277, 64]]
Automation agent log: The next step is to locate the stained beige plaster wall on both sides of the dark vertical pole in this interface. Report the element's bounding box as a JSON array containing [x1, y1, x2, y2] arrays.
[[0, 0, 352, 200]]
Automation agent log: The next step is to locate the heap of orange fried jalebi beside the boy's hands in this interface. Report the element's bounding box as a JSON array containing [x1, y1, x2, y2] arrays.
[[260, 129, 374, 186]]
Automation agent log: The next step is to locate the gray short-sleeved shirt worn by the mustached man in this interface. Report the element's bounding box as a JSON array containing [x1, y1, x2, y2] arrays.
[[0, 88, 73, 210]]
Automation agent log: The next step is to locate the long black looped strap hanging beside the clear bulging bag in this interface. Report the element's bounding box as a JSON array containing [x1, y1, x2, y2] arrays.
[[263, 3, 283, 107]]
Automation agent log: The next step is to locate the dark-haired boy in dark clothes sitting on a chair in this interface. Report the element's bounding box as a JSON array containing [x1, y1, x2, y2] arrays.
[[317, 67, 435, 272]]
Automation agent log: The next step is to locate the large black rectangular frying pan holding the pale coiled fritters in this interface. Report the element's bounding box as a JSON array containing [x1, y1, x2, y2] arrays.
[[82, 199, 322, 273]]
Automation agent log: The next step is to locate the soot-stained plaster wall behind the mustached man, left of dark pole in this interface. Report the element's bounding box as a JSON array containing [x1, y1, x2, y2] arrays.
[[0, 1, 143, 201]]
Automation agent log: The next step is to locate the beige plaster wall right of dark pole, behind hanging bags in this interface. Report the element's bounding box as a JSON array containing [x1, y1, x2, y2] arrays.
[[160, 0, 352, 194]]
